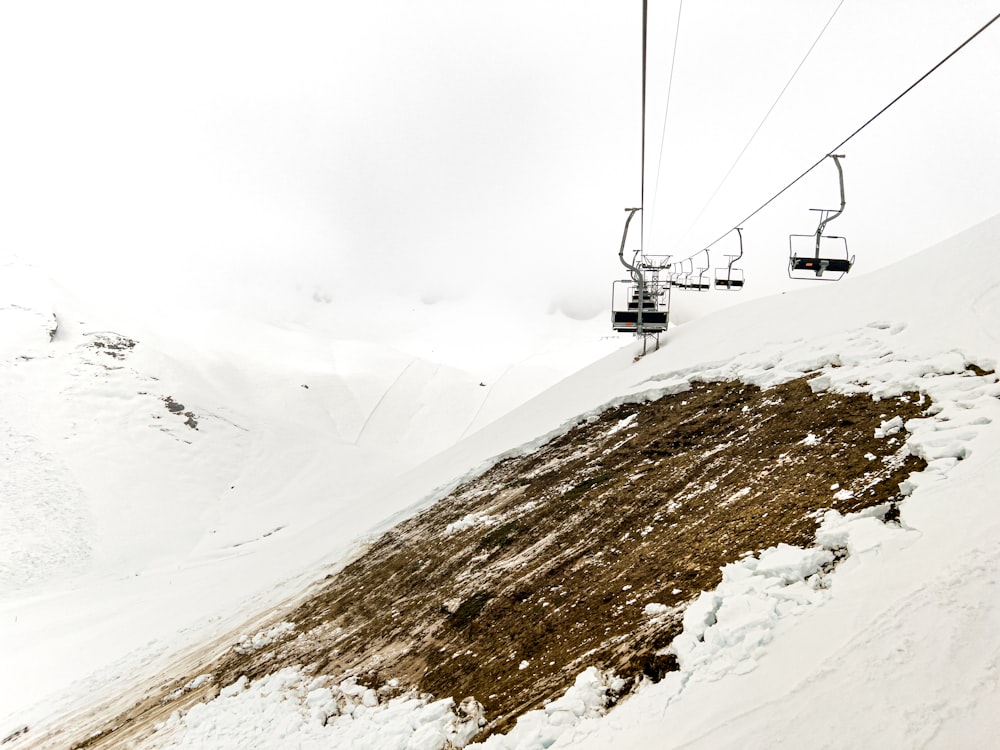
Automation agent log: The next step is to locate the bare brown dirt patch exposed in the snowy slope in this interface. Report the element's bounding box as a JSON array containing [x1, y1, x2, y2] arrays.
[[64, 378, 929, 747]]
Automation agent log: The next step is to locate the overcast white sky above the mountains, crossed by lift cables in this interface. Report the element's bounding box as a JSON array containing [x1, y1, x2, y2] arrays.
[[0, 0, 1000, 328]]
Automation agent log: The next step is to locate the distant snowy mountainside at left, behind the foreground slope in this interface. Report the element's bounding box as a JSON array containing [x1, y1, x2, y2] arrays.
[[0, 263, 616, 736]]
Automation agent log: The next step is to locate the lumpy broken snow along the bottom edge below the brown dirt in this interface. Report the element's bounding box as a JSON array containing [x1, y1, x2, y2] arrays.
[[149, 667, 625, 750]]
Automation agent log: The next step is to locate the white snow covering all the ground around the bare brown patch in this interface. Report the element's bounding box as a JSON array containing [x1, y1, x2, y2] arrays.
[[0, 210, 1000, 750]]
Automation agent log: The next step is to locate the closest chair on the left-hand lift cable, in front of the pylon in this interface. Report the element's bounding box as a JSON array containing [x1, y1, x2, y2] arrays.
[[611, 208, 670, 341]]
